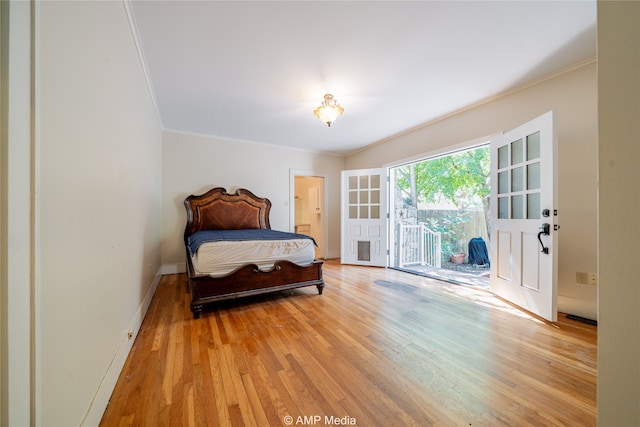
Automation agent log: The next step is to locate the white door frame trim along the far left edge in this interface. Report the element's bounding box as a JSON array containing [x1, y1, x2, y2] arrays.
[[0, 1, 36, 425]]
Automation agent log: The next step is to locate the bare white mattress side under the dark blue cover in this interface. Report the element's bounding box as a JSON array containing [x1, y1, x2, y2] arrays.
[[191, 238, 315, 277]]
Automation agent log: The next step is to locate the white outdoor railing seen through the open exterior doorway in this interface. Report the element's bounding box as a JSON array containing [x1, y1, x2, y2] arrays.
[[399, 223, 442, 268]]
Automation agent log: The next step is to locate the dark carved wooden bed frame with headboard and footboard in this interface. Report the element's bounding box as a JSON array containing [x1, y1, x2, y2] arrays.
[[184, 187, 324, 319]]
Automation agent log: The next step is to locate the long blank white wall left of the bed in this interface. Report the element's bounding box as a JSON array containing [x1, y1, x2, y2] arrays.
[[34, 1, 162, 426]]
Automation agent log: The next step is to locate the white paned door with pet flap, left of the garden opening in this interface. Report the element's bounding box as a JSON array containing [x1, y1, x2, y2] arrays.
[[340, 169, 388, 267]]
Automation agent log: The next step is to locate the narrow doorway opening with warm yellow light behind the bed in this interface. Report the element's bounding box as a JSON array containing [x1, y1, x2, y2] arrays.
[[292, 175, 326, 259]]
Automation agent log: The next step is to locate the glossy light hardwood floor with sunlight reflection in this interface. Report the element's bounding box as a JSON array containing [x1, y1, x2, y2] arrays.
[[101, 261, 597, 427]]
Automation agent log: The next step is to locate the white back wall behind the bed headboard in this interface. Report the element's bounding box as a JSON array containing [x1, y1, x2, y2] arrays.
[[162, 131, 344, 271]]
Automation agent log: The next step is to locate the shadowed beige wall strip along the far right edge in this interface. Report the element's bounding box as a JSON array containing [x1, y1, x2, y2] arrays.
[[598, 1, 640, 427]]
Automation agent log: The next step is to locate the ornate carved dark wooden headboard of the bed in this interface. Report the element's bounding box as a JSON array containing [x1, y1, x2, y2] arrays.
[[184, 187, 271, 239]]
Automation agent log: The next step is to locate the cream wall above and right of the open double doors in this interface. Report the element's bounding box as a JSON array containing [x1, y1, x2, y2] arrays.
[[345, 62, 597, 319]]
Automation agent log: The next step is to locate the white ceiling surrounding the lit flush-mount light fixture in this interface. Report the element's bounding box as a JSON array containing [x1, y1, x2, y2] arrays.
[[131, 0, 596, 154]]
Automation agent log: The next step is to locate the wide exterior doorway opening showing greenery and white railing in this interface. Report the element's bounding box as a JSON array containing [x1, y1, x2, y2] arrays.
[[389, 144, 491, 288]]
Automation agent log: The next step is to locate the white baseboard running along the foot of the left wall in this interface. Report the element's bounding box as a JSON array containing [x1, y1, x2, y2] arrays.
[[81, 267, 168, 427]]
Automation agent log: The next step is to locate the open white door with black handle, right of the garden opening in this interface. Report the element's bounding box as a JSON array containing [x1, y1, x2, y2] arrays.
[[490, 111, 558, 322]]
